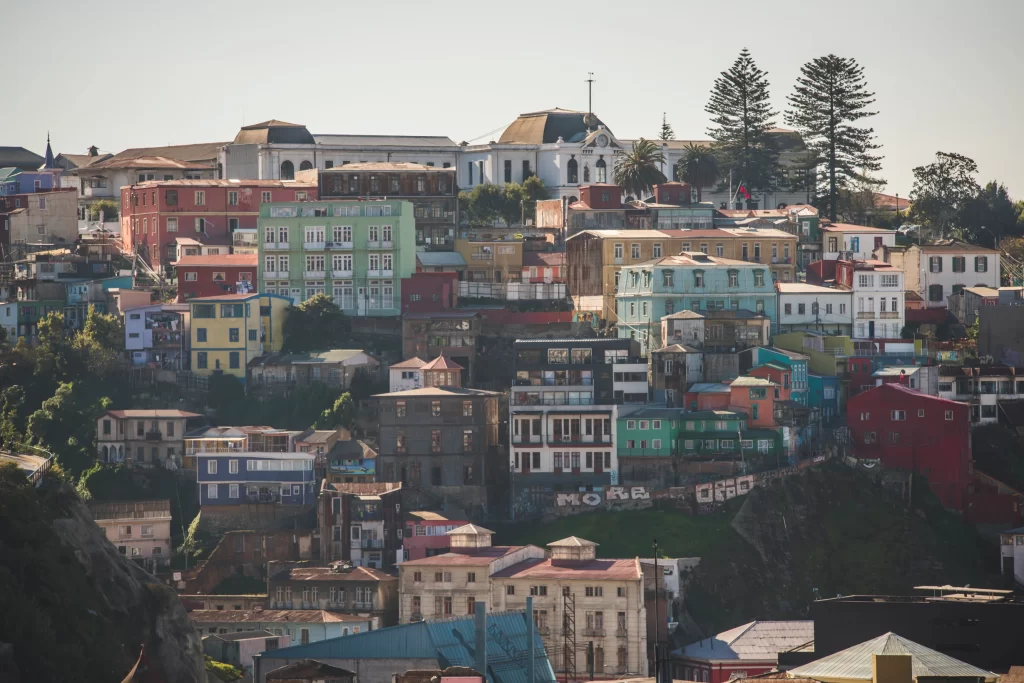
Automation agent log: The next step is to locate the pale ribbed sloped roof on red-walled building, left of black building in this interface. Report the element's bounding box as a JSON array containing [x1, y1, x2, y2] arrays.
[[681, 621, 814, 663]]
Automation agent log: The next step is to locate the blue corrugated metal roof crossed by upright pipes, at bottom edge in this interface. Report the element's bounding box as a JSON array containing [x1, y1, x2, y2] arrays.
[[260, 611, 555, 683]]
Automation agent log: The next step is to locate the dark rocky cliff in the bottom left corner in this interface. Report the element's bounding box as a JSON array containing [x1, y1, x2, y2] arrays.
[[0, 466, 206, 683]]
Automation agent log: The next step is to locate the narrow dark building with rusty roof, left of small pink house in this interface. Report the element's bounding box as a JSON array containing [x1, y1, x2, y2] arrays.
[[316, 481, 402, 569]]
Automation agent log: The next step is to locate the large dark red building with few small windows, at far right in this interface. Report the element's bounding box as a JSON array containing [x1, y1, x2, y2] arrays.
[[847, 384, 972, 512]]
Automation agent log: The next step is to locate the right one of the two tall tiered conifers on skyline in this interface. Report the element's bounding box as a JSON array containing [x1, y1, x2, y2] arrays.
[[785, 54, 885, 220]]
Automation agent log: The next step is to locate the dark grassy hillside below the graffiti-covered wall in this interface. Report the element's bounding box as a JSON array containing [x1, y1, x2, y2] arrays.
[[495, 464, 998, 638]]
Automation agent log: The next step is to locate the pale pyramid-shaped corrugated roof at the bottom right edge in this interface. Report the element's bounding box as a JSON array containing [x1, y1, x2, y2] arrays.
[[790, 632, 996, 681]]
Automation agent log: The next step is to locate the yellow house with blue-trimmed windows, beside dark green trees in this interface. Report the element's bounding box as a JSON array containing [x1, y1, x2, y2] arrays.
[[188, 294, 290, 383]]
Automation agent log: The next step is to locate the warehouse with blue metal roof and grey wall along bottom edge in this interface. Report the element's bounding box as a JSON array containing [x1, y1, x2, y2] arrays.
[[253, 610, 555, 683]]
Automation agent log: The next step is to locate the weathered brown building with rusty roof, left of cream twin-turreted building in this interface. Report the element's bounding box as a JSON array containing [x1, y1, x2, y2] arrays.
[[266, 562, 398, 629]]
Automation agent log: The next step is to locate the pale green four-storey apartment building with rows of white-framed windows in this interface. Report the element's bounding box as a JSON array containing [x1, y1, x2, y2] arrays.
[[259, 200, 416, 316]]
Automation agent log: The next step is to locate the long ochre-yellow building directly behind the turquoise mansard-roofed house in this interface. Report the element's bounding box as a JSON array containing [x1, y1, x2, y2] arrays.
[[565, 227, 797, 322]]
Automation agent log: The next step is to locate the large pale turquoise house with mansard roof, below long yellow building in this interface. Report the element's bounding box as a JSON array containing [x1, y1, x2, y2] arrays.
[[615, 252, 778, 353]]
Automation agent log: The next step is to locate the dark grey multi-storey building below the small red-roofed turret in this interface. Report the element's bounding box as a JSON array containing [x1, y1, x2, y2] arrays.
[[374, 387, 504, 509]]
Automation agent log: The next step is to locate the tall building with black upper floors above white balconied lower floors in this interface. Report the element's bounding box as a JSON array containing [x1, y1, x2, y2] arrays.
[[509, 338, 647, 489]]
